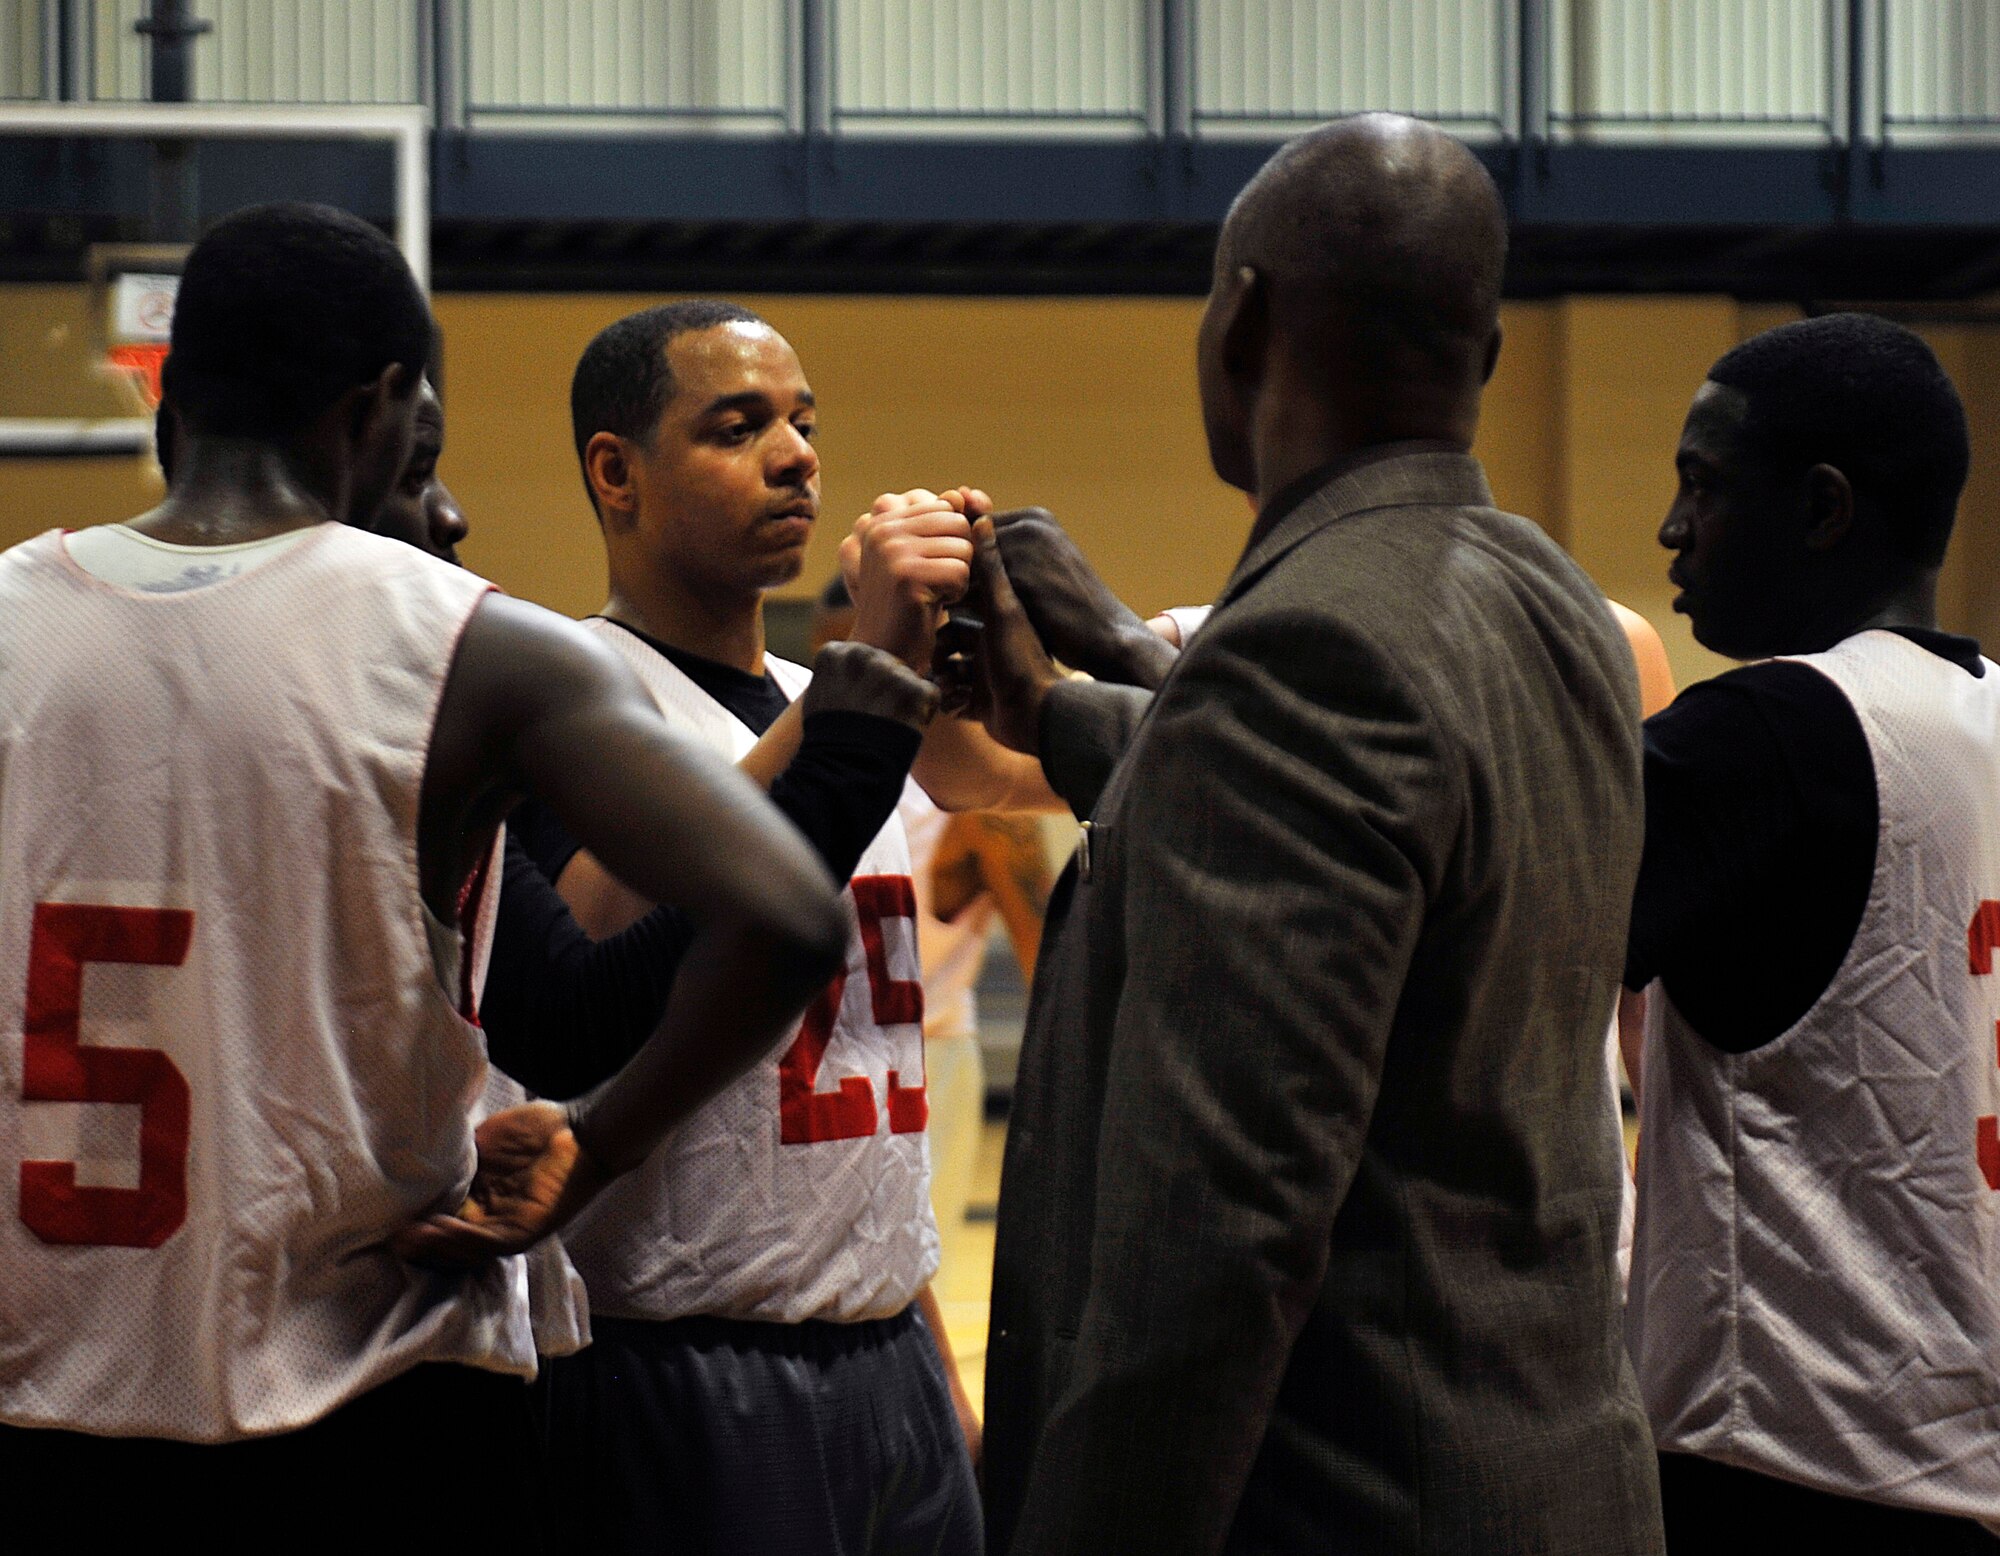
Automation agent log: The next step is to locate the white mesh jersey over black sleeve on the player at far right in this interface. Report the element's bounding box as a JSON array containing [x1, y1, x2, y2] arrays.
[[1626, 632, 2000, 1522]]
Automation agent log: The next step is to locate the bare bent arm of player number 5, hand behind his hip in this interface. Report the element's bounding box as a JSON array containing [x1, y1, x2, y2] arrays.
[[398, 594, 846, 1264]]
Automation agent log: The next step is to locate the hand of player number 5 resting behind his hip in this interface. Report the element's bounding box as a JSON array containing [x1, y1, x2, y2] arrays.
[[390, 1102, 606, 1270]]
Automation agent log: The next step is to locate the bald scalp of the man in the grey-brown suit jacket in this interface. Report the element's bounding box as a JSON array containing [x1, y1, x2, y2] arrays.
[[1216, 114, 1506, 376]]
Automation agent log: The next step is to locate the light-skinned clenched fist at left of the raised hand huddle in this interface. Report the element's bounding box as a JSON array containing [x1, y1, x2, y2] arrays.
[[842, 492, 972, 672]]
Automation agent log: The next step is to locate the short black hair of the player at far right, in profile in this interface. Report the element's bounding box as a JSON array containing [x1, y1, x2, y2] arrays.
[[1708, 314, 1972, 568]]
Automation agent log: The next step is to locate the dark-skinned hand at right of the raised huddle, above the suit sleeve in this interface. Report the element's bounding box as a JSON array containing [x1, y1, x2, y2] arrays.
[[994, 508, 1174, 686]]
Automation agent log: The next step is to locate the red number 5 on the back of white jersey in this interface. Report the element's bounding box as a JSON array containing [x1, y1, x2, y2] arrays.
[[20, 902, 194, 1248]]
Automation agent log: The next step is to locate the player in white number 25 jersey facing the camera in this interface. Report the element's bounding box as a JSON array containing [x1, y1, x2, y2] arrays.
[[524, 302, 978, 1552]]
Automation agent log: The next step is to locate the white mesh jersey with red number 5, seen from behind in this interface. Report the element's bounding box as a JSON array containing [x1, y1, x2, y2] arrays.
[[0, 524, 534, 1442]]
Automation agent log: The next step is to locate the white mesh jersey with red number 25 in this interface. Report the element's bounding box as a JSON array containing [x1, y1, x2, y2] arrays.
[[564, 620, 938, 1324]]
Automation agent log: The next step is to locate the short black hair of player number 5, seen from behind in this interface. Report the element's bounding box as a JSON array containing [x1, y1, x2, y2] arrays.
[[162, 202, 432, 442]]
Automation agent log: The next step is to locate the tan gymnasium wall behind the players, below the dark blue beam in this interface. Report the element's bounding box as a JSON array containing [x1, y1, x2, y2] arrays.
[[0, 288, 2000, 682]]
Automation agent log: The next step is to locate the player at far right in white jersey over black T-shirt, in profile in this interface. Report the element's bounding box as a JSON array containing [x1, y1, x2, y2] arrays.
[[1624, 314, 2000, 1556]]
